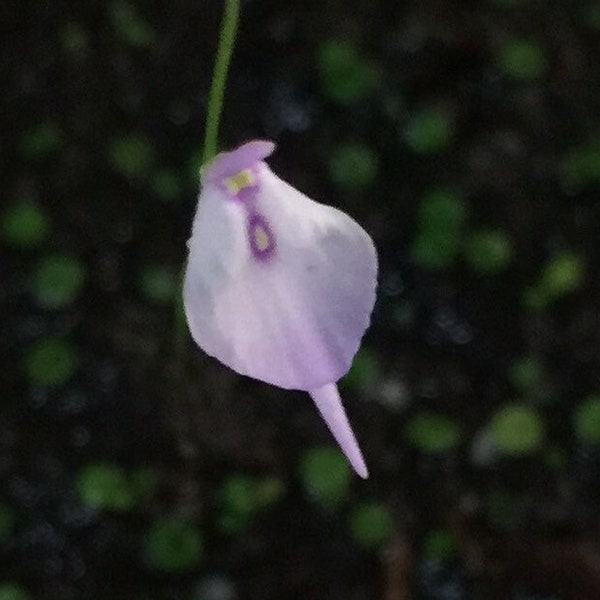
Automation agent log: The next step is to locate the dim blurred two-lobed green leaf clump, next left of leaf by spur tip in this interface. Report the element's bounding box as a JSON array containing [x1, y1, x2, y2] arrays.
[[217, 474, 285, 534]]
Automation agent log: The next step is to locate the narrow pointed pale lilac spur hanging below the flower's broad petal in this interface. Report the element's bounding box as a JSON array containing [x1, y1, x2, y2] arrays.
[[309, 383, 369, 479]]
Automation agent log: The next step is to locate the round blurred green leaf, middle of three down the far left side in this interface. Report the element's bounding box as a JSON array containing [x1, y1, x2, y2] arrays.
[[30, 254, 86, 309]]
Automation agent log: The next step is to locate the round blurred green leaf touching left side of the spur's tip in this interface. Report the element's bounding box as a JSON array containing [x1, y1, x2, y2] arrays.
[[300, 446, 352, 511]]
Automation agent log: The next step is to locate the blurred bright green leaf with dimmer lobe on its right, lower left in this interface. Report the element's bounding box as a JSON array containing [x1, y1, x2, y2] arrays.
[[75, 463, 157, 512]]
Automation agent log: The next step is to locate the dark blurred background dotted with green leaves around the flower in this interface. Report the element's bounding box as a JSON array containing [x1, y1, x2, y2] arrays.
[[0, 0, 600, 600]]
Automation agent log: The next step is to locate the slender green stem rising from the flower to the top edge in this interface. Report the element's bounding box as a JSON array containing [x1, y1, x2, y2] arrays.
[[202, 0, 240, 164]]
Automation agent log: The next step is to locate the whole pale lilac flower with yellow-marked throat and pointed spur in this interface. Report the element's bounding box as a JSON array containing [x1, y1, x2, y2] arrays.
[[183, 140, 377, 477]]
